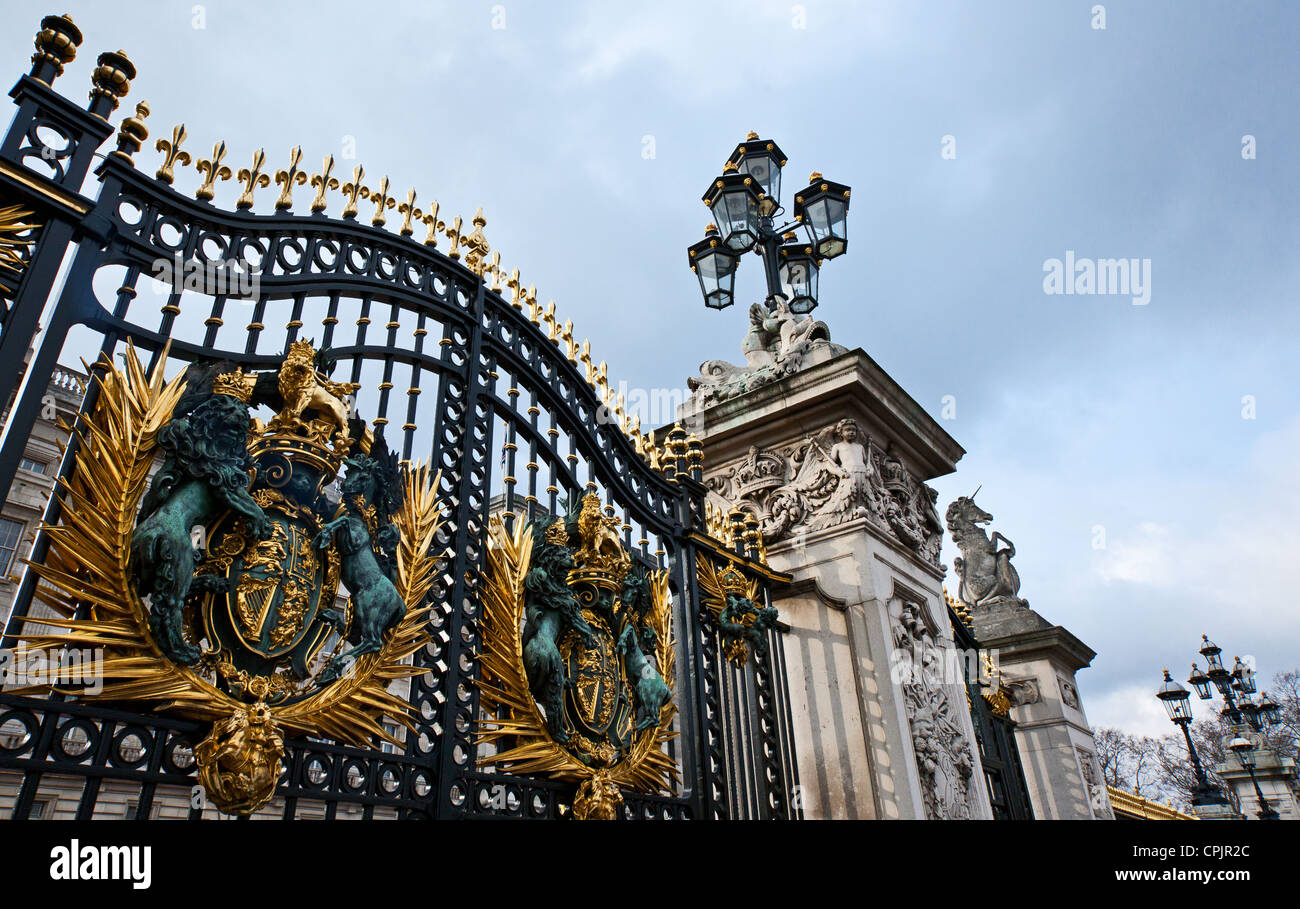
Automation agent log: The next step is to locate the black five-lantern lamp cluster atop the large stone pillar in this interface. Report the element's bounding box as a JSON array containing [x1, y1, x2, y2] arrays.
[[686, 133, 849, 315]]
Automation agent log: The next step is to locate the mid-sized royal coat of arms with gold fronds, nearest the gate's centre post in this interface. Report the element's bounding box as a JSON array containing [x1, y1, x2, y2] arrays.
[[480, 493, 677, 819]]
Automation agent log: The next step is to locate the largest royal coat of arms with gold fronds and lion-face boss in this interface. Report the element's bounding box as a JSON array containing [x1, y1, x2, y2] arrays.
[[7, 341, 441, 814]]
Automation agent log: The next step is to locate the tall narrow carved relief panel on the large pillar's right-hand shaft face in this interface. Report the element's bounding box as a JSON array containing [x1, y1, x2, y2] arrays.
[[893, 602, 975, 821]]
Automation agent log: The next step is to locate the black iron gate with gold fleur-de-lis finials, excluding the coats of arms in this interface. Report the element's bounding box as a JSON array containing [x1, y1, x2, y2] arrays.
[[0, 17, 800, 819]]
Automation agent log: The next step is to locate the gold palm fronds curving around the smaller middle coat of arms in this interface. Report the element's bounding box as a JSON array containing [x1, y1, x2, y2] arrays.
[[478, 518, 677, 793]]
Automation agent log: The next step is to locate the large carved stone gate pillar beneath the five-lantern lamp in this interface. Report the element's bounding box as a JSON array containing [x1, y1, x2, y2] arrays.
[[681, 345, 992, 818]]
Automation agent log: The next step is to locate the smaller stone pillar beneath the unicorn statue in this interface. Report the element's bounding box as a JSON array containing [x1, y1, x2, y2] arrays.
[[971, 599, 1114, 821]]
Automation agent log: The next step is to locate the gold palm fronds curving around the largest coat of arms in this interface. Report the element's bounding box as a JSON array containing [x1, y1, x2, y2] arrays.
[[7, 346, 442, 813]]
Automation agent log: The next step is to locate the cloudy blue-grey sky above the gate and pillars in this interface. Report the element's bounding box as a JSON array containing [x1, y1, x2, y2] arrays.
[[0, 0, 1300, 733]]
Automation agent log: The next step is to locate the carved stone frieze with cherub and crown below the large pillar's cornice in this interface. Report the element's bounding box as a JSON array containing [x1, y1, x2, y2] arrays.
[[706, 420, 944, 567]]
